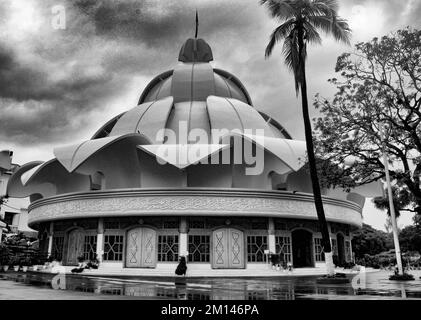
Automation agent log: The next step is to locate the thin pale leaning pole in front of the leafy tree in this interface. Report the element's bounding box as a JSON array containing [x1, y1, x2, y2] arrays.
[[380, 128, 403, 275]]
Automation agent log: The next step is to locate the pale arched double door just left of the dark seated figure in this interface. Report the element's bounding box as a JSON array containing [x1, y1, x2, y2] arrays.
[[126, 227, 157, 268]]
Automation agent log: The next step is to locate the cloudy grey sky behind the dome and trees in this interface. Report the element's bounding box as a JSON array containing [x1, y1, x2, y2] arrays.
[[0, 0, 421, 228]]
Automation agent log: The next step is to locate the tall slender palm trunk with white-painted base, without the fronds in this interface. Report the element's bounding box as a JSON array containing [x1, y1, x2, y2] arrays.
[[300, 35, 335, 275]]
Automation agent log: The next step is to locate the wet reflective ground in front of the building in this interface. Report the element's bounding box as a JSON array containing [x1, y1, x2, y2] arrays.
[[0, 271, 421, 300]]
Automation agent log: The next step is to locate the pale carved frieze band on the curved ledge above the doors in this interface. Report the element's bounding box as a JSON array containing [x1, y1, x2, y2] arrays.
[[29, 194, 361, 225]]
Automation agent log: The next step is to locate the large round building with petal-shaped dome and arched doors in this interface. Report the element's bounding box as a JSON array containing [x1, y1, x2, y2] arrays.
[[7, 39, 365, 275]]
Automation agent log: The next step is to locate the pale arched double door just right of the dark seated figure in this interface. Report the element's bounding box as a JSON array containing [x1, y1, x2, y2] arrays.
[[212, 228, 244, 269]]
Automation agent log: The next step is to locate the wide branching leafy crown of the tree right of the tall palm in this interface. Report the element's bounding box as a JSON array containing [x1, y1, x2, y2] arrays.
[[315, 28, 421, 213]]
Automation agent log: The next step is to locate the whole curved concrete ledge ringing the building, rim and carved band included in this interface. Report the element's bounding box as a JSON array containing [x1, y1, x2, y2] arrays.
[[29, 188, 362, 227]]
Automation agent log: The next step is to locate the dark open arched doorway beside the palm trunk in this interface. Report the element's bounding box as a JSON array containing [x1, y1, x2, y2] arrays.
[[292, 229, 314, 268]]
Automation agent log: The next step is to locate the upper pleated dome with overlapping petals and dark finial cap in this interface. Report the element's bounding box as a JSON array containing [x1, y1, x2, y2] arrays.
[[93, 39, 291, 143]]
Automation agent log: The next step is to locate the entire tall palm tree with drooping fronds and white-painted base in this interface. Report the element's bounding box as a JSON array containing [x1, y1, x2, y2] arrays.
[[260, 0, 351, 275]]
